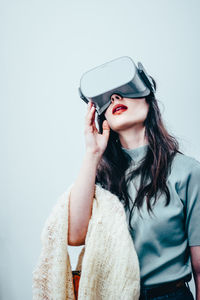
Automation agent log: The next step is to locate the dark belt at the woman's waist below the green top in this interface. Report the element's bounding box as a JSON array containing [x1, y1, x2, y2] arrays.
[[140, 279, 186, 299]]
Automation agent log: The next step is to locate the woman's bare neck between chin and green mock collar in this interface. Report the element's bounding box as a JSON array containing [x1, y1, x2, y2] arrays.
[[118, 126, 148, 149]]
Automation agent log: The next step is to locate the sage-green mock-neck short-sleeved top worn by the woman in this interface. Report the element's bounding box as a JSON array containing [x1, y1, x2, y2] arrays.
[[122, 145, 200, 286]]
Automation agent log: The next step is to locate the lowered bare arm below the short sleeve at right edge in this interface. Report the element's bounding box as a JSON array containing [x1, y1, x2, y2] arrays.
[[190, 246, 200, 300]]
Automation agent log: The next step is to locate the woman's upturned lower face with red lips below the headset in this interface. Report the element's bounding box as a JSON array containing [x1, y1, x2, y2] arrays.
[[104, 94, 149, 132]]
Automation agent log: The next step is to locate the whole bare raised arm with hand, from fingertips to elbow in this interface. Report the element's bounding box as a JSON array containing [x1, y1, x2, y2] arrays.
[[68, 102, 110, 246]]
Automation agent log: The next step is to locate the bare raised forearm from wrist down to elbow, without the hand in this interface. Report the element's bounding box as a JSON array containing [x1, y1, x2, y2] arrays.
[[68, 152, 100, 245]]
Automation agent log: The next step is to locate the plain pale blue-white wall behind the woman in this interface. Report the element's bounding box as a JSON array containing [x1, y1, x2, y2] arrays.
[[0, 0, 200, 300]]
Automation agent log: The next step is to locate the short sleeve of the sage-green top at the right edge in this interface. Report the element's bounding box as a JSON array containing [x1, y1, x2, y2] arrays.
[[186, 161, 200, 246]]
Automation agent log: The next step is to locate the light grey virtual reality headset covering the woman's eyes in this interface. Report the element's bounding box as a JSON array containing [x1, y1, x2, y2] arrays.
[[79, 56, 155, 115]]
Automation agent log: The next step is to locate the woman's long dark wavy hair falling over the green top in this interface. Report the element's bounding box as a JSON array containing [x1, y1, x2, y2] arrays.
[[95, 77, 182, 227]]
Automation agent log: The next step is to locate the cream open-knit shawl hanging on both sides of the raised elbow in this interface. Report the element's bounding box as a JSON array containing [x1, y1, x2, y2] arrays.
[[32, 184, 140, 300]]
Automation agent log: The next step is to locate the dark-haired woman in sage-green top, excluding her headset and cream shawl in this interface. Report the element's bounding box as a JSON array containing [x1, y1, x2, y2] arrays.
[[69, 77, 200, 300]]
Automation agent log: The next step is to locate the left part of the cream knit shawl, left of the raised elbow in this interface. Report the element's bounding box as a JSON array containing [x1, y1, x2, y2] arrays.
[[32, 184, 75, 300]]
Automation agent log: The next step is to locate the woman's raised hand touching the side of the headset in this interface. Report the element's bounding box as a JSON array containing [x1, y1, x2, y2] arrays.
[[84, 101, 110, 158]]
